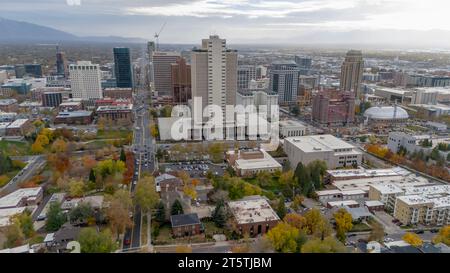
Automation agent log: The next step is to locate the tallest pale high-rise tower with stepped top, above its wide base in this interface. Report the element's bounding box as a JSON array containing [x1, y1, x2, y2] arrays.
[[191, 35, 237, 110]]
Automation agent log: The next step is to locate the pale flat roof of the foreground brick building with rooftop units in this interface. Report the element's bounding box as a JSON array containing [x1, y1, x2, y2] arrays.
[[228, 196, 280, 224]]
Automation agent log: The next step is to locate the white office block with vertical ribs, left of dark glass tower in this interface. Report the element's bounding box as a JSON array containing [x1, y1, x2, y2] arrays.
[[69, 61, 103, 100]]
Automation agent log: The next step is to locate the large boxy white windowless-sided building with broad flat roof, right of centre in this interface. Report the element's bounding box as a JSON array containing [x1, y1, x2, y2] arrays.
[[284, 135, 362, 169]]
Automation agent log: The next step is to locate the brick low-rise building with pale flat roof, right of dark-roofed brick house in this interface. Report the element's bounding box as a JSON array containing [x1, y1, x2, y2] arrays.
[[228, 195, 280, 237]]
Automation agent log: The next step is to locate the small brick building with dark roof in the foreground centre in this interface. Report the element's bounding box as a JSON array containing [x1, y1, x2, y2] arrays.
[[170, 213, 204, 237]]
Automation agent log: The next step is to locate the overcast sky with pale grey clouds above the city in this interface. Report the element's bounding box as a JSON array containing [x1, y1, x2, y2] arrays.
[[0, 0, 450, 43]]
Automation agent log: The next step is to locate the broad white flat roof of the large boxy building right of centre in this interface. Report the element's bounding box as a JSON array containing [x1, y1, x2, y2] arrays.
[[285, 135, 357, 153]]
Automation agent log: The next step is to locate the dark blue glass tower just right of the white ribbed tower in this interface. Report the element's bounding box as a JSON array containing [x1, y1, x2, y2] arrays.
[[113, 47, 133, 88]]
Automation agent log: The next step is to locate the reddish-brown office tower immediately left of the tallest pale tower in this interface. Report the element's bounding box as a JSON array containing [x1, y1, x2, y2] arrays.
[[170, 57, 191, 104]]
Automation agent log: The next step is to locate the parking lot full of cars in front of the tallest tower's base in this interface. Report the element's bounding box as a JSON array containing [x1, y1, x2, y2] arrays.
[[160, 161, 226, 177]]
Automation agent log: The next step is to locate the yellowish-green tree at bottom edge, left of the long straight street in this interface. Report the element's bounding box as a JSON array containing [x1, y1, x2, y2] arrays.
[[78, 227, 116, 253]]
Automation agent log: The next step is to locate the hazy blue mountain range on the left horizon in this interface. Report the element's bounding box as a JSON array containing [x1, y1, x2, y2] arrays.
[[0, 17, 145, 43]]
